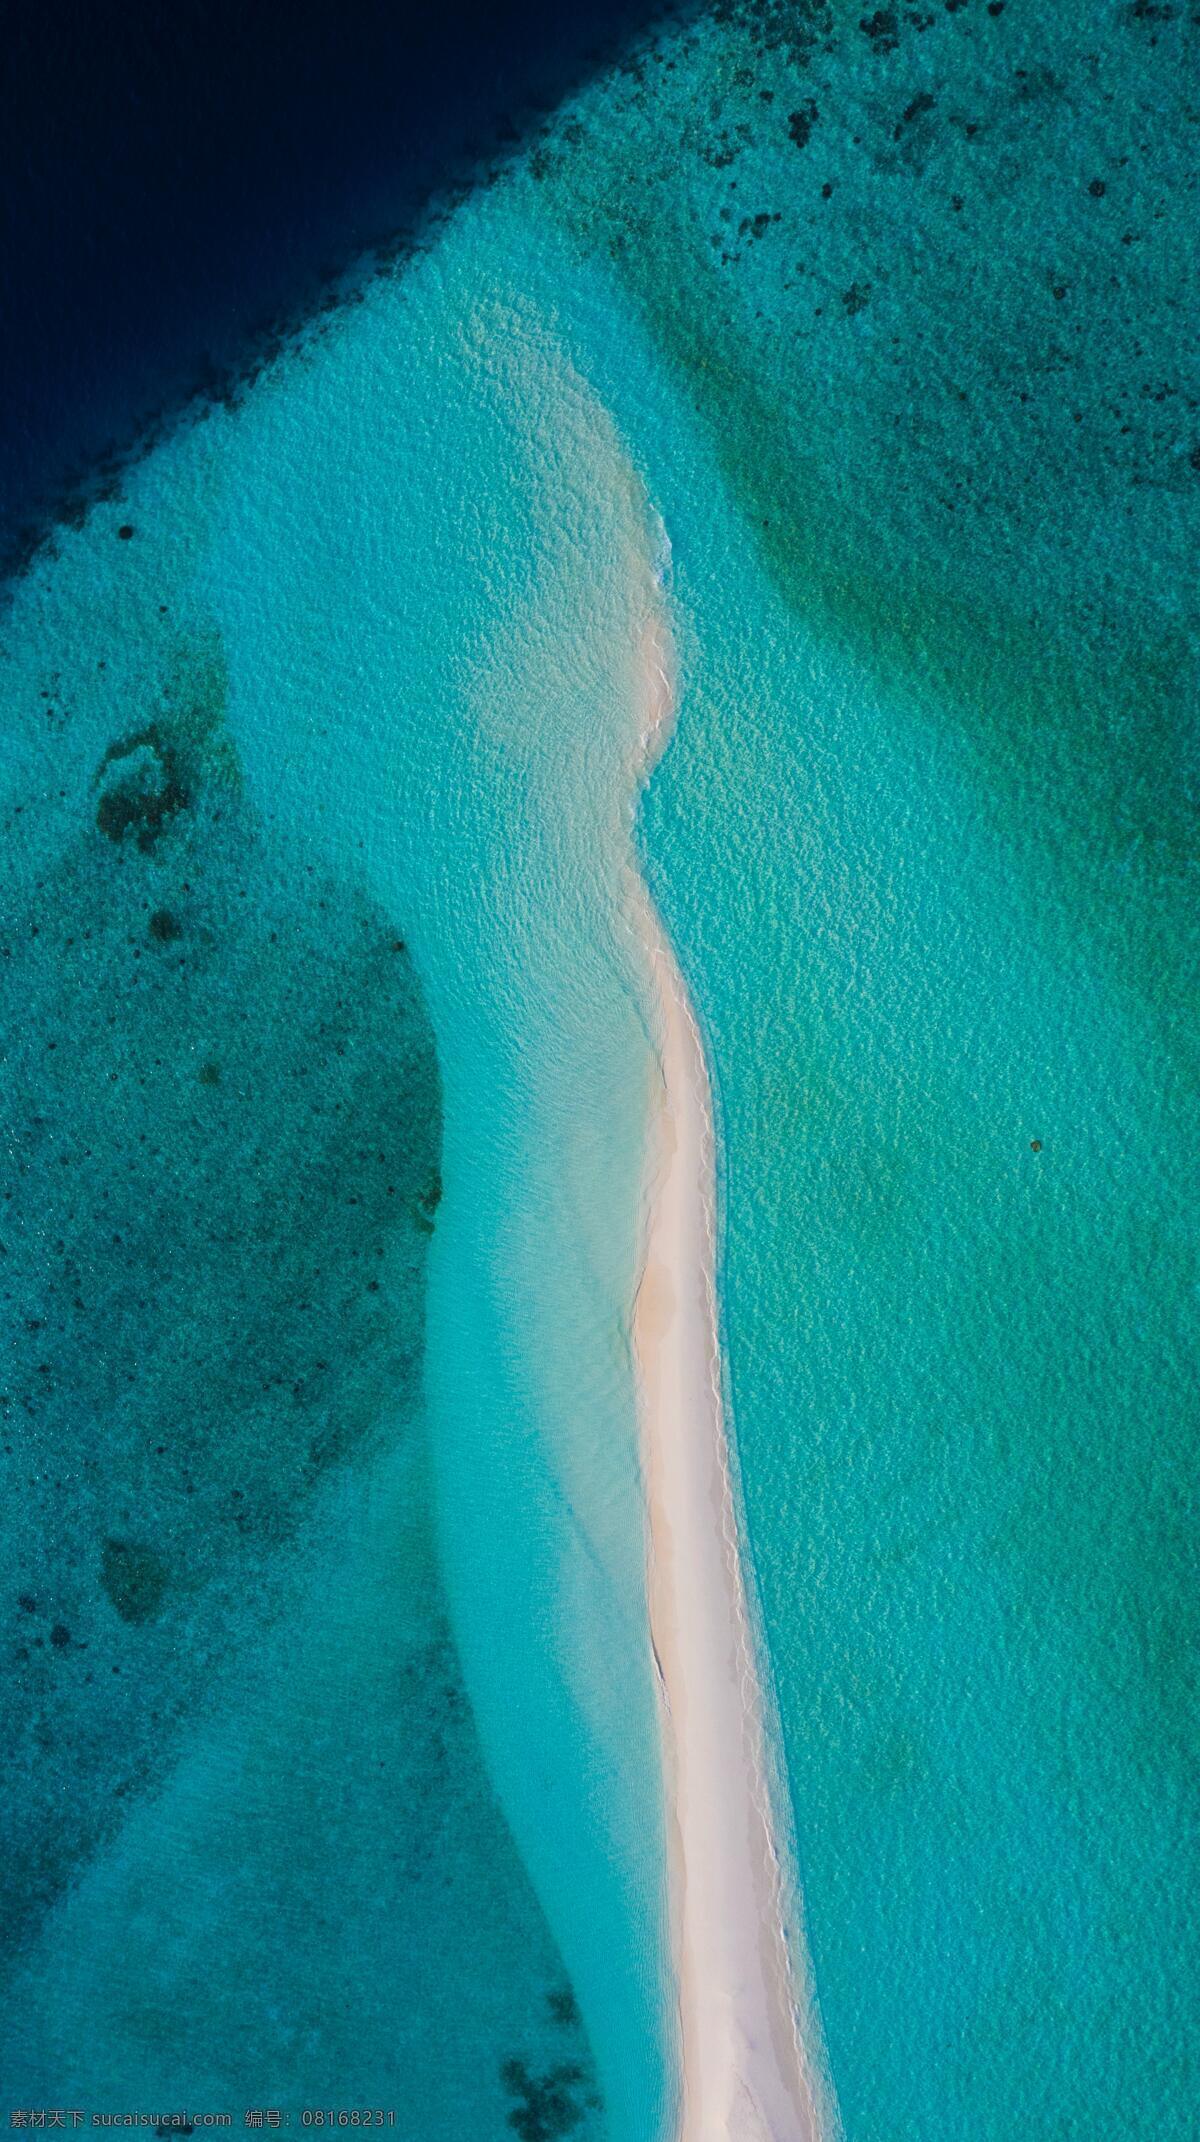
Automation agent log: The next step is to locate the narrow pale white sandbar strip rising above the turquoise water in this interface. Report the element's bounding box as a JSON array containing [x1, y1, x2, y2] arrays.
[[628, 621, 829, 2142]]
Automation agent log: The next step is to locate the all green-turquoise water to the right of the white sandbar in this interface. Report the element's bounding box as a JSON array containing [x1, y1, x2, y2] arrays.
[[531, 6, 1200, 2138]]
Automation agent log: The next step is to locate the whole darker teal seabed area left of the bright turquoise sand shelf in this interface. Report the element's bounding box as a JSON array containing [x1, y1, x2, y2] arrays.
[[0, 539, 600, 2142]]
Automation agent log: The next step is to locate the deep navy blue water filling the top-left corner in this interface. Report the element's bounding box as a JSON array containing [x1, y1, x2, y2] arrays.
[[0, 0, 677, 565]]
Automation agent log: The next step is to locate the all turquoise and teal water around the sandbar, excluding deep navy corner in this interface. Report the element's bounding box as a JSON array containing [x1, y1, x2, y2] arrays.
[[0, 0, 1200, 2142]]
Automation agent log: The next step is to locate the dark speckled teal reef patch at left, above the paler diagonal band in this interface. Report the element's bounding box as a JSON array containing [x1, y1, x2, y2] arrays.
[[0, 625, 439, 1941]]
